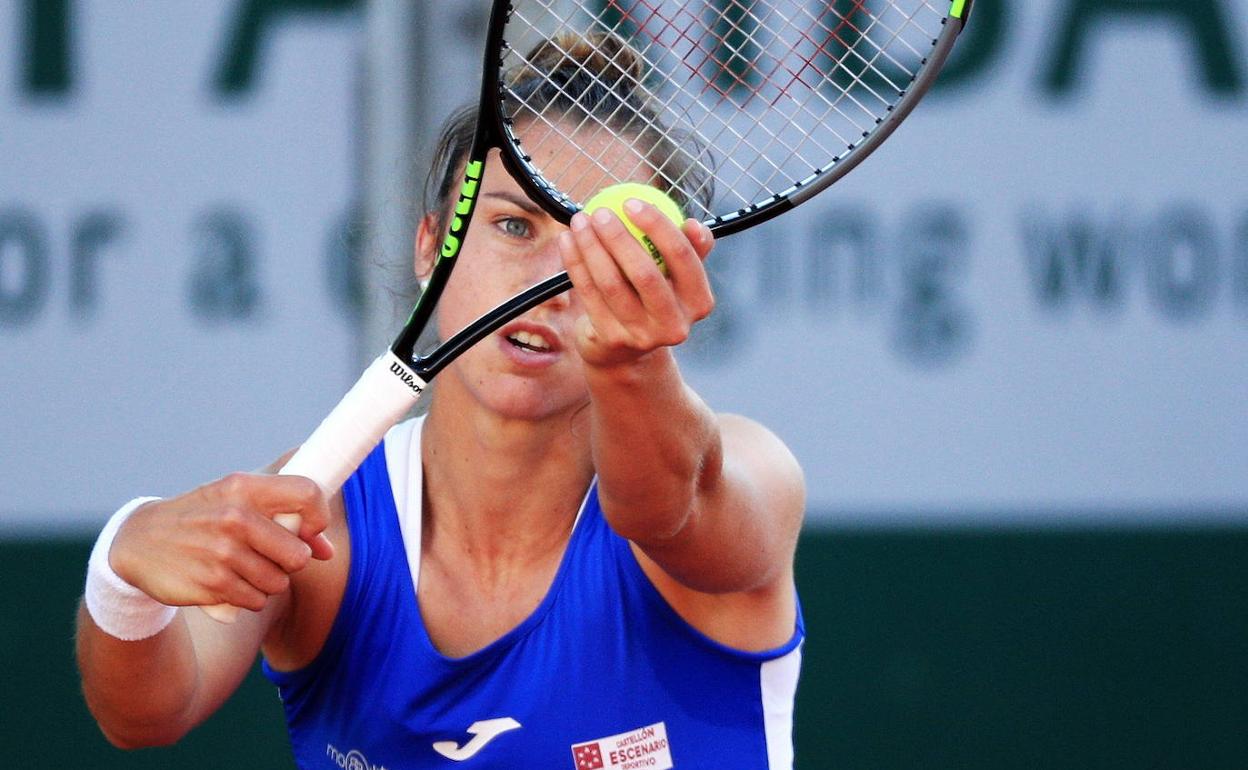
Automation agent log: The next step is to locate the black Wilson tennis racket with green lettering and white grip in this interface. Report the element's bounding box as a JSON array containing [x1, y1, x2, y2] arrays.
[[205, 0, 971, 621]]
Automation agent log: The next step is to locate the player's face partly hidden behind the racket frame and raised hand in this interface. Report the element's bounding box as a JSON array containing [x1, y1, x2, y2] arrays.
[[422, 121, 649, 419]]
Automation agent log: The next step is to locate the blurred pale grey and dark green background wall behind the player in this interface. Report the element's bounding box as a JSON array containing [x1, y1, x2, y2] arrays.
[[0, 0, 1248, 769]]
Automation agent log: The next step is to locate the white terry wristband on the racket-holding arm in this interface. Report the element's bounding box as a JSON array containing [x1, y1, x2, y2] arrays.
[[85, 497, 177, 641]]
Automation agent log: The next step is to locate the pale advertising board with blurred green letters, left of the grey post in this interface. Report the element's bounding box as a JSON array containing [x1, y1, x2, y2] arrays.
[[0, 0, 362, 529]]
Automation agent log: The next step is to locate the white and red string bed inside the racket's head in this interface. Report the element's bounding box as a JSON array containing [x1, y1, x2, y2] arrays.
[[504, 0, 943, 218]]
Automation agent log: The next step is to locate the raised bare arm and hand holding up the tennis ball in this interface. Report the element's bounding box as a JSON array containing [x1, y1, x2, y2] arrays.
[[560, 205, 805, 646]]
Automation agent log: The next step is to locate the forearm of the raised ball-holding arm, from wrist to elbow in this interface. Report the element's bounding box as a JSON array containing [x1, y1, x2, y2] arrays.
[[587, 348, 723, 543]]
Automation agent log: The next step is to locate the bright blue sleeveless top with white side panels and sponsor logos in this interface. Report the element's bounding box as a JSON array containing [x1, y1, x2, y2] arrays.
[[263, 431, 804, 770]]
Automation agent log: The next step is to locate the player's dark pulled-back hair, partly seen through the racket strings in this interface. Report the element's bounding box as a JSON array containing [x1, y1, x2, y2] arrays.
[[422, 32, 711, 242]]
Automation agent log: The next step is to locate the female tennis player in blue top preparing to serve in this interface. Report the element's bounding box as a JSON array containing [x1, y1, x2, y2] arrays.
[[77, 33, 804, 770]]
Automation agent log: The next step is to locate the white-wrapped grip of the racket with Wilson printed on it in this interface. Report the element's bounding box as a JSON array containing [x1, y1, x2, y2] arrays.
[[203, 351, 426, 623]]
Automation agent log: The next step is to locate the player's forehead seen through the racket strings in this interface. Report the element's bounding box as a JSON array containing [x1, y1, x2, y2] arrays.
[[487, 121, 655, 203]]
